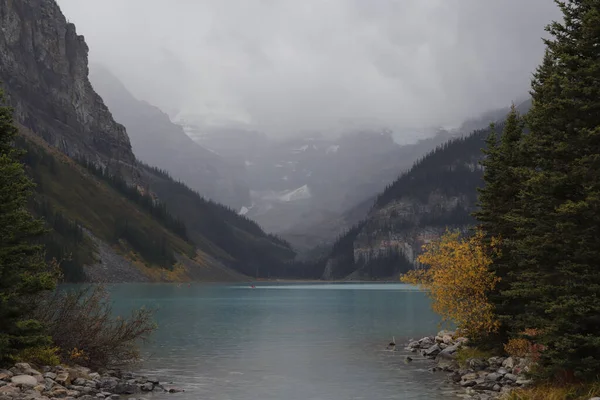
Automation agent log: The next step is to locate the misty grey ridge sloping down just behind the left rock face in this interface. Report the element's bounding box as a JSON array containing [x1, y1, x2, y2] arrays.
[[90, 65, 250, 210]]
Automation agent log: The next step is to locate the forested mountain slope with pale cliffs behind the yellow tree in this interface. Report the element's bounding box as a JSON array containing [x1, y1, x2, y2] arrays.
[[321, 101, 530, 279]]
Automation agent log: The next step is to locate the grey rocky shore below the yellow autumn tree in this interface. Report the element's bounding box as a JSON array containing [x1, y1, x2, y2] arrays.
[[406, 331, 531, 400]]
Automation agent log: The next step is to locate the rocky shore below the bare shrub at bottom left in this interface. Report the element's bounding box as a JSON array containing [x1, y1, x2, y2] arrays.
[[0, 363, 182, 400]]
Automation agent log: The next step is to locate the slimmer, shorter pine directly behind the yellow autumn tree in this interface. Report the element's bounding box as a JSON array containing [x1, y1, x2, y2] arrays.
[[473, 105, 523, 344]]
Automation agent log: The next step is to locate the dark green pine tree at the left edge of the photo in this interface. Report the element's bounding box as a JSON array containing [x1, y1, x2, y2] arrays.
[[0, 92, 54, 363]]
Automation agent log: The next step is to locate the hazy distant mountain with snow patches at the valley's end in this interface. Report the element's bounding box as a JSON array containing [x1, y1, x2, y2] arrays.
[[181, 120, 447, 234]]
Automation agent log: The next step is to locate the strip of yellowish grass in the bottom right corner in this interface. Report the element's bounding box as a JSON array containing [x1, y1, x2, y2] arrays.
[[503, 381, 600, 400]]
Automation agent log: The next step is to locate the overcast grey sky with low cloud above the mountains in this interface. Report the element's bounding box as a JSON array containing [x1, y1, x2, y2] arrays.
[[58, 0, 559, 135]]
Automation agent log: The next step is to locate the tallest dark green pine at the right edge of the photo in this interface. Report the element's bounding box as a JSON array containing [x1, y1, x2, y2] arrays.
[[505, 0, 600, 379]]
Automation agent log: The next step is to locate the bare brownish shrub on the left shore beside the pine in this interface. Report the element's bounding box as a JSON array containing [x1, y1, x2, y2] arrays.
[[35, 286, 156, 368]]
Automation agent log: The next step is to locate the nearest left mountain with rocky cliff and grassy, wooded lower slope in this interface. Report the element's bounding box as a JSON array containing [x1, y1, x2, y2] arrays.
[[0, 0, 294, 282]]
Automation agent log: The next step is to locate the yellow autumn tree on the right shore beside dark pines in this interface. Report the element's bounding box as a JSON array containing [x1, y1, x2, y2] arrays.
[[401, 231, 500, 338]]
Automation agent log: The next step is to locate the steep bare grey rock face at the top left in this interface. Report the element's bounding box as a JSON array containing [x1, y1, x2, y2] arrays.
[[0, 0, 135, 166]]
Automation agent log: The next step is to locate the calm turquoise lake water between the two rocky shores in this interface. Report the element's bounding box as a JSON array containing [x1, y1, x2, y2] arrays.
[[106, 284, 452, 400]]
